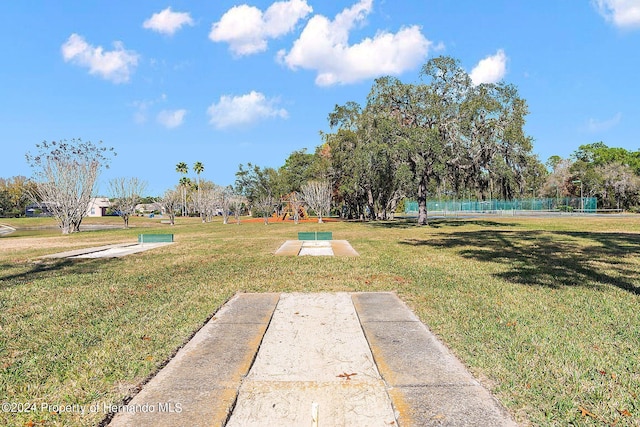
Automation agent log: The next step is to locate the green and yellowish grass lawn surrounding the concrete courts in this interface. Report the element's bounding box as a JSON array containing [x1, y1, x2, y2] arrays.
[[0, 217, 640, 426]]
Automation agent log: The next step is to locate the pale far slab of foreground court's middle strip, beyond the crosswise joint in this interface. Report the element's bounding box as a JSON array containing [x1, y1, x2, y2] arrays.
[[240, 293, 380, 382]]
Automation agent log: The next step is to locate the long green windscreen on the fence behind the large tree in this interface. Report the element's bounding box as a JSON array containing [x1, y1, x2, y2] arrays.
[[404, 197, 597, 215]]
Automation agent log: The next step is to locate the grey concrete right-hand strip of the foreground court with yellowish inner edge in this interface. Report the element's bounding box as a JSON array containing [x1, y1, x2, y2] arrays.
[[352, 293, 516, 426]]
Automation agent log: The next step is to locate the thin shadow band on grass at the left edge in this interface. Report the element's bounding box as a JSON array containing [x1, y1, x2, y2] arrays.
[[0, 258, 111, 289]]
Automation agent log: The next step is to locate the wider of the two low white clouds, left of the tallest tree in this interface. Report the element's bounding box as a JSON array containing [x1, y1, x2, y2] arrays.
[[207, 91, 289, 129]]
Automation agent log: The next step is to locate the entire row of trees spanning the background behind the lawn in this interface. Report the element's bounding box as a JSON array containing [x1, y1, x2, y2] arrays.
[[5, 56, 640, 233]]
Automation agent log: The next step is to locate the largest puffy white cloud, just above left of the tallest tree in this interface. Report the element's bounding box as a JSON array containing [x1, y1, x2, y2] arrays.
[[278, 0, 432, 86]]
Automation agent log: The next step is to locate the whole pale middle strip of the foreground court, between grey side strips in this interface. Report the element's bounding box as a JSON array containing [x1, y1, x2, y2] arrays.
[[227, 293, 396, 426]]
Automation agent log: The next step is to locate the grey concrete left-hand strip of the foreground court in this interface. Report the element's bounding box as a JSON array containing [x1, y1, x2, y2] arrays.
[[110, 294, 279, 427]]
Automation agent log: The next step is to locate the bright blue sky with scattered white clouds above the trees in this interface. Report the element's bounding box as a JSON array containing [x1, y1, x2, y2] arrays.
[[0, 0, 640, 195]]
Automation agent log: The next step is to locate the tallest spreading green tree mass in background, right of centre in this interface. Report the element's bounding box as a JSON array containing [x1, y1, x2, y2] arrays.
[[236, 57, 545, 224]]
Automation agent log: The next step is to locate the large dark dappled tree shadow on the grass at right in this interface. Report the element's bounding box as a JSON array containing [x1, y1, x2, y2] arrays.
[[401, 230, 640, 295]]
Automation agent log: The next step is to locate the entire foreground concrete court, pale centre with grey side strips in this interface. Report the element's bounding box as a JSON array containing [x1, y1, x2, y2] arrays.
[[110, 292, 516, 427]]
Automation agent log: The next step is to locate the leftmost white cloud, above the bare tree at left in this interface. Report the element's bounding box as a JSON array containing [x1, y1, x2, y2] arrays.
[[61, 33, 138, 83]]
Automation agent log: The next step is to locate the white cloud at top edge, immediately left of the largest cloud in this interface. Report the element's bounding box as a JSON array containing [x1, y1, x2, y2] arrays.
[[209, 0, 313, 56]]
